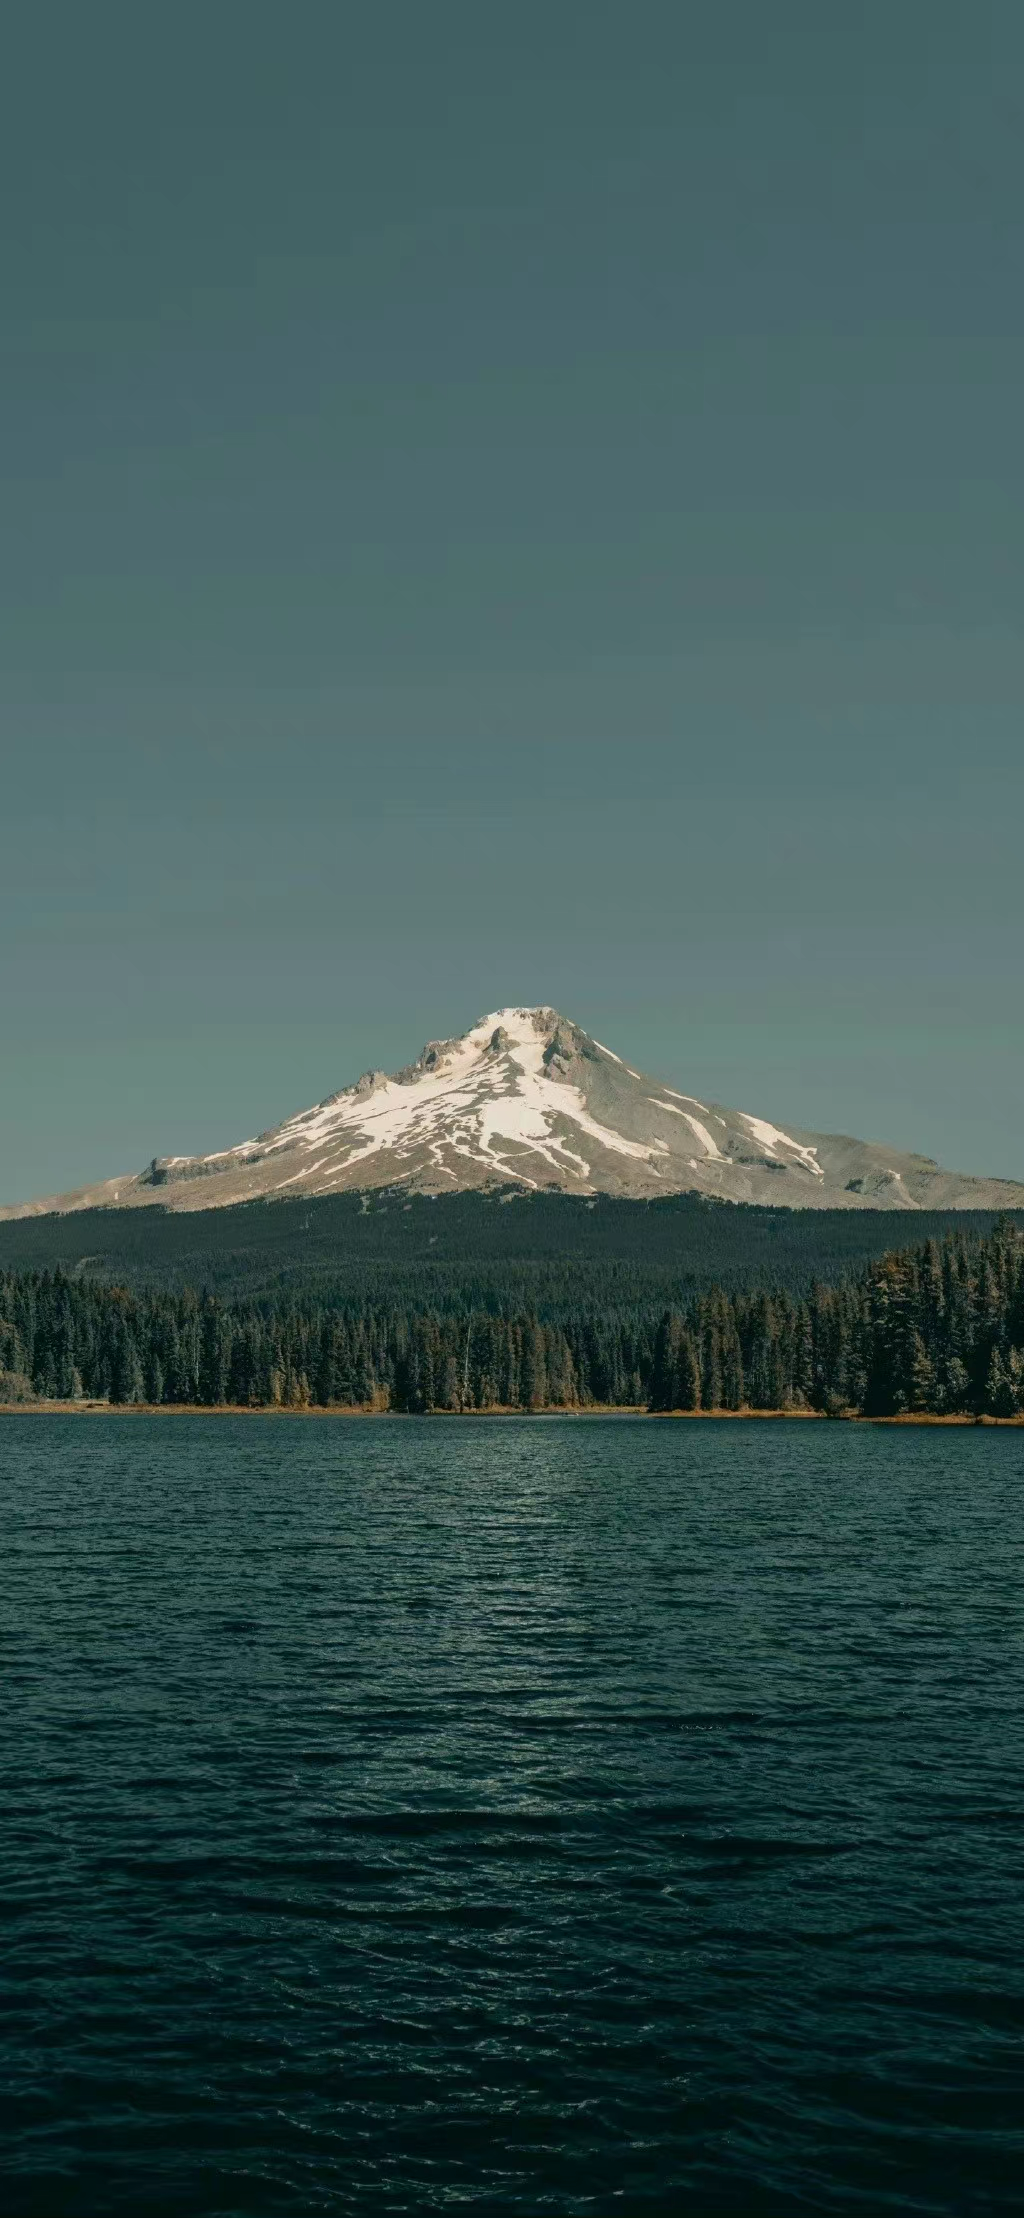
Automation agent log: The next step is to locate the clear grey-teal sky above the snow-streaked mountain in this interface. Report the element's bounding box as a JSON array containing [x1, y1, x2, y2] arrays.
[[0, 0, 1024, 1200]]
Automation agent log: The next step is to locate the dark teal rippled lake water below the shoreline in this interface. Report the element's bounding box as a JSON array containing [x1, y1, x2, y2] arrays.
[[0, 1417, 1024, 2218]]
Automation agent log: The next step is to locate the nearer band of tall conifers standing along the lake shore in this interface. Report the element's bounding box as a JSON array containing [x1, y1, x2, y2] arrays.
[[0, 1220, 1024, 1417]]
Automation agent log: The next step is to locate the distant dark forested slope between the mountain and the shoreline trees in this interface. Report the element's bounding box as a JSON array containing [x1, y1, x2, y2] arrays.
[[0, 1189, 1024, 1317]]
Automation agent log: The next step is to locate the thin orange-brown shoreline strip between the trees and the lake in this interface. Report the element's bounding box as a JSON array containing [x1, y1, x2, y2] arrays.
[[0, 1397, 1024, 1428]]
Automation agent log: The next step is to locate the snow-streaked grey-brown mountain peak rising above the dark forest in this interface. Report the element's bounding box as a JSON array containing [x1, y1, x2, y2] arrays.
[[0, 1009, 1024, 1218]]
